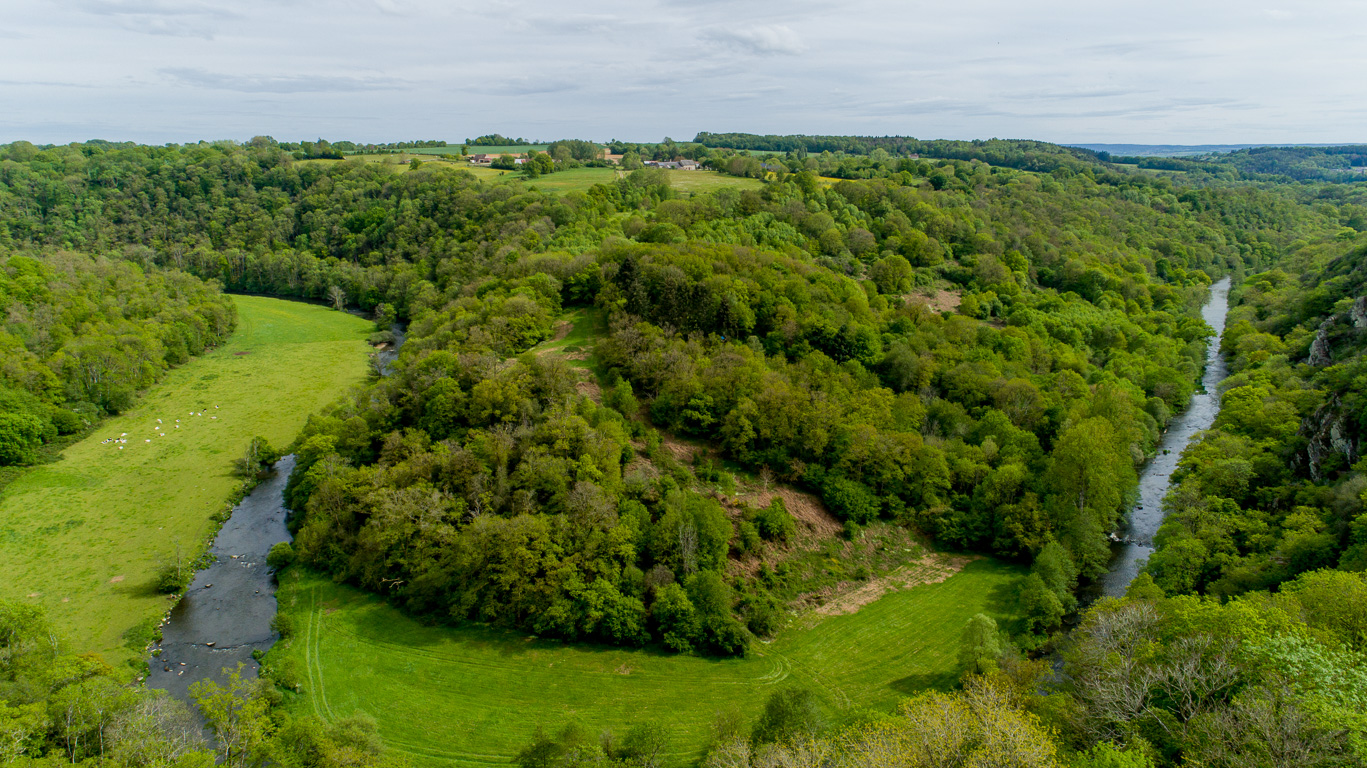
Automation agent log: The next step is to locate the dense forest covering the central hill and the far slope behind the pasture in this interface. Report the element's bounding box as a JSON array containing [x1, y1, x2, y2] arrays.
[[0, 135, 1341, 645]]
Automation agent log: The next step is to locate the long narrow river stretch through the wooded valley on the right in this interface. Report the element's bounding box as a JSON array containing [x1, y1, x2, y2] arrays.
[[1102, 277, 1229, 597]]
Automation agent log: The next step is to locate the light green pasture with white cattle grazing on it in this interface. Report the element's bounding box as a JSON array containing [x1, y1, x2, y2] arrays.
[[0, 297, 373, 663]]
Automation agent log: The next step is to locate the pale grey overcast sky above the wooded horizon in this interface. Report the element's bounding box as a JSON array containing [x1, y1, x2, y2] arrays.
[[0, 0, 1367, 143]]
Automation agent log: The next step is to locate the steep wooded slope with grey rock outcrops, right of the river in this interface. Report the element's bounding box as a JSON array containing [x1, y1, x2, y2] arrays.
[[1148, 228, 1367, 596]]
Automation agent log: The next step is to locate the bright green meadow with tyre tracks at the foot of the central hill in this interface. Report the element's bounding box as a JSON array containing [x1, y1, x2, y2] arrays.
[[267, 559, 1021, 765]]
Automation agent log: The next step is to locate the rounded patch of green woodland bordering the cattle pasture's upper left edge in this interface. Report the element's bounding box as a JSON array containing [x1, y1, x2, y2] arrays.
[[0, 250, 236, 465]]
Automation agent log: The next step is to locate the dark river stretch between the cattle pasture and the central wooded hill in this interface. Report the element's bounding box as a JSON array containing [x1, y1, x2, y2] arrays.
[[148, 455, 294, 701]]
